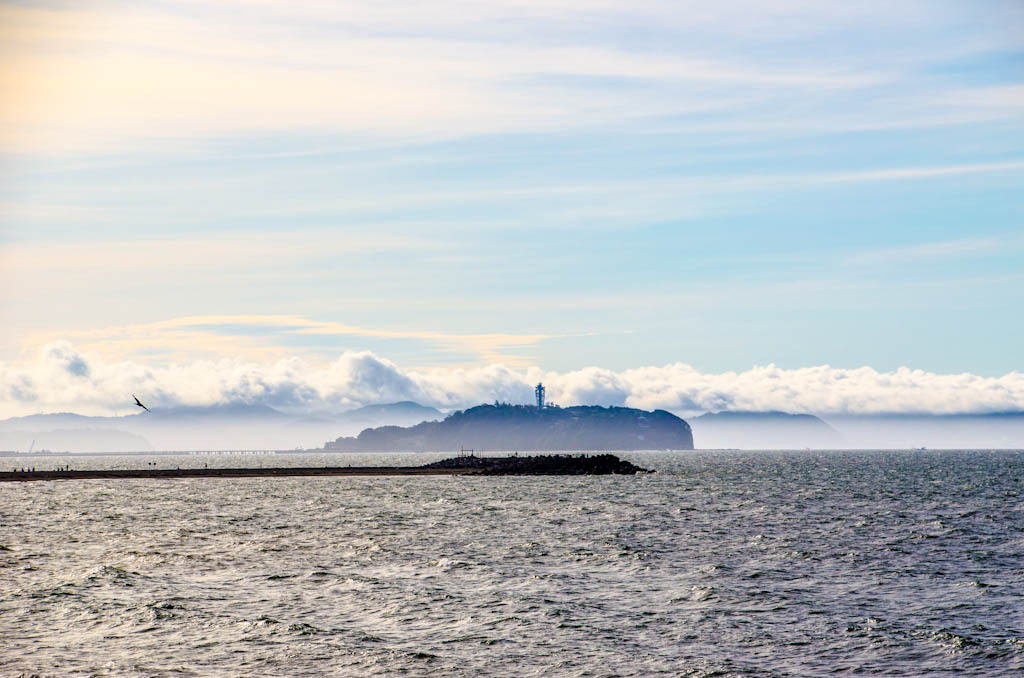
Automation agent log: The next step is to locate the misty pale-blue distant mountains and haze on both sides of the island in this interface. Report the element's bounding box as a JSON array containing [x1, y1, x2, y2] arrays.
[[0, 387, 1024, 454]]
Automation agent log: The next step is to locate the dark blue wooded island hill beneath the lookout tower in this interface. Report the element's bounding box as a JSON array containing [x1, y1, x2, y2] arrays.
[[324, 404, 693, 452]]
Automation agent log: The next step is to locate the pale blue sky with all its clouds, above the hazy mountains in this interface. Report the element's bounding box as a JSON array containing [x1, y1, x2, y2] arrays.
[[0, 0, 1024, 416]]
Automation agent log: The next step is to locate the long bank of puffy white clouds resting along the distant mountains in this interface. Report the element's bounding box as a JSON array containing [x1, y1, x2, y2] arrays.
[[0, 341, 1024, 417]]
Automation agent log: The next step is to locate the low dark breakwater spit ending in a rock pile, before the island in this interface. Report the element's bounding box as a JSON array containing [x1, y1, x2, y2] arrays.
[[0, 455, 649, 482]]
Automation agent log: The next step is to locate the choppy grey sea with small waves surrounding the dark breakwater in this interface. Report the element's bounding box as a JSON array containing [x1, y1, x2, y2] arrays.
[[0, 451, 1024, 676]]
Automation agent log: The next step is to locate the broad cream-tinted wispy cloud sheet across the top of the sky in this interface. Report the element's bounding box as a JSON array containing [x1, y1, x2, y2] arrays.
[[0, 2, 1019, 151]]
